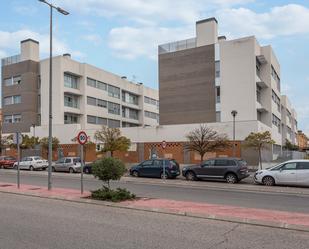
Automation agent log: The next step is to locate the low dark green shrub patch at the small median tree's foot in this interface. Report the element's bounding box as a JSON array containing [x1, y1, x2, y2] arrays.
[[91, 187, 136, 202]]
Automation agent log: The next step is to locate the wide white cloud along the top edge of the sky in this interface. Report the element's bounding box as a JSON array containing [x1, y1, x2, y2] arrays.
[[55, 0, 254, 23]]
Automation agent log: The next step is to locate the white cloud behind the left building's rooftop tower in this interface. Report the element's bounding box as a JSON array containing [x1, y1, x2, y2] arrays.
[[0, 29, 83, 57]]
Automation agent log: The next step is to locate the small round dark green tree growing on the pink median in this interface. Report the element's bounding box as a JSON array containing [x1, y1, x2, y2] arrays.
[[92, 157, 126, 190]]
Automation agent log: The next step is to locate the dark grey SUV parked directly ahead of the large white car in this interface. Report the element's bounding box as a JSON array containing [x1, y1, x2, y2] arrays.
[[182, 157, 249, 183]]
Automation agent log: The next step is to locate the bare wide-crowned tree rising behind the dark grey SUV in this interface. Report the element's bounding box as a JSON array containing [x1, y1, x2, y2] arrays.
[[185, 125, 231, 162]]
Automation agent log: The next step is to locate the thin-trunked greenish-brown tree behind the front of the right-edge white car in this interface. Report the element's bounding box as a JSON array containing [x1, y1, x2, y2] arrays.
[[244, 131, 275, 169]]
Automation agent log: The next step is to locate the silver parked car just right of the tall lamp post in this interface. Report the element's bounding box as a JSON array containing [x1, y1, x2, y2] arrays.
[[52, 157, 81, 173]]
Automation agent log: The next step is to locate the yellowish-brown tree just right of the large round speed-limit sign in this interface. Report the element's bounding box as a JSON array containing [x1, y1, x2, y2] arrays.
[[94, 126, 131, 157]]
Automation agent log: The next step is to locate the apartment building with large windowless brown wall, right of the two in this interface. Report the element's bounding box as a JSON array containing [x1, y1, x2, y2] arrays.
[[159, 18, 297, 151]]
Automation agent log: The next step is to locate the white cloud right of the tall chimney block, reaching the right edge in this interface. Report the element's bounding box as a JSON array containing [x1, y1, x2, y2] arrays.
[[216, 4, 309, 39]]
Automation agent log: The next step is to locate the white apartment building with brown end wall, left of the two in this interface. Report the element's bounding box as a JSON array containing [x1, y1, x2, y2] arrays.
[[2, 39, 159, 136]]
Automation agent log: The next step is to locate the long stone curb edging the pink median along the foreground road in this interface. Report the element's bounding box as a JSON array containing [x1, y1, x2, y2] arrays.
[[0, 190, 309, 233]]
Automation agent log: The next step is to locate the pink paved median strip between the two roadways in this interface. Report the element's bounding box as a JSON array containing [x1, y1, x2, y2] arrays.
[[0, 182, 309, 232]]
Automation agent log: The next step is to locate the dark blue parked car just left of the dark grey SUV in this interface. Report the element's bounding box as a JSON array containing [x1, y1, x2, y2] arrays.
[[130, 159, 180, 178]]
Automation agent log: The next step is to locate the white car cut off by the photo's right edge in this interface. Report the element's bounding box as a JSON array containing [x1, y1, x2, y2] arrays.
[[254, 160, 309, 186]]
